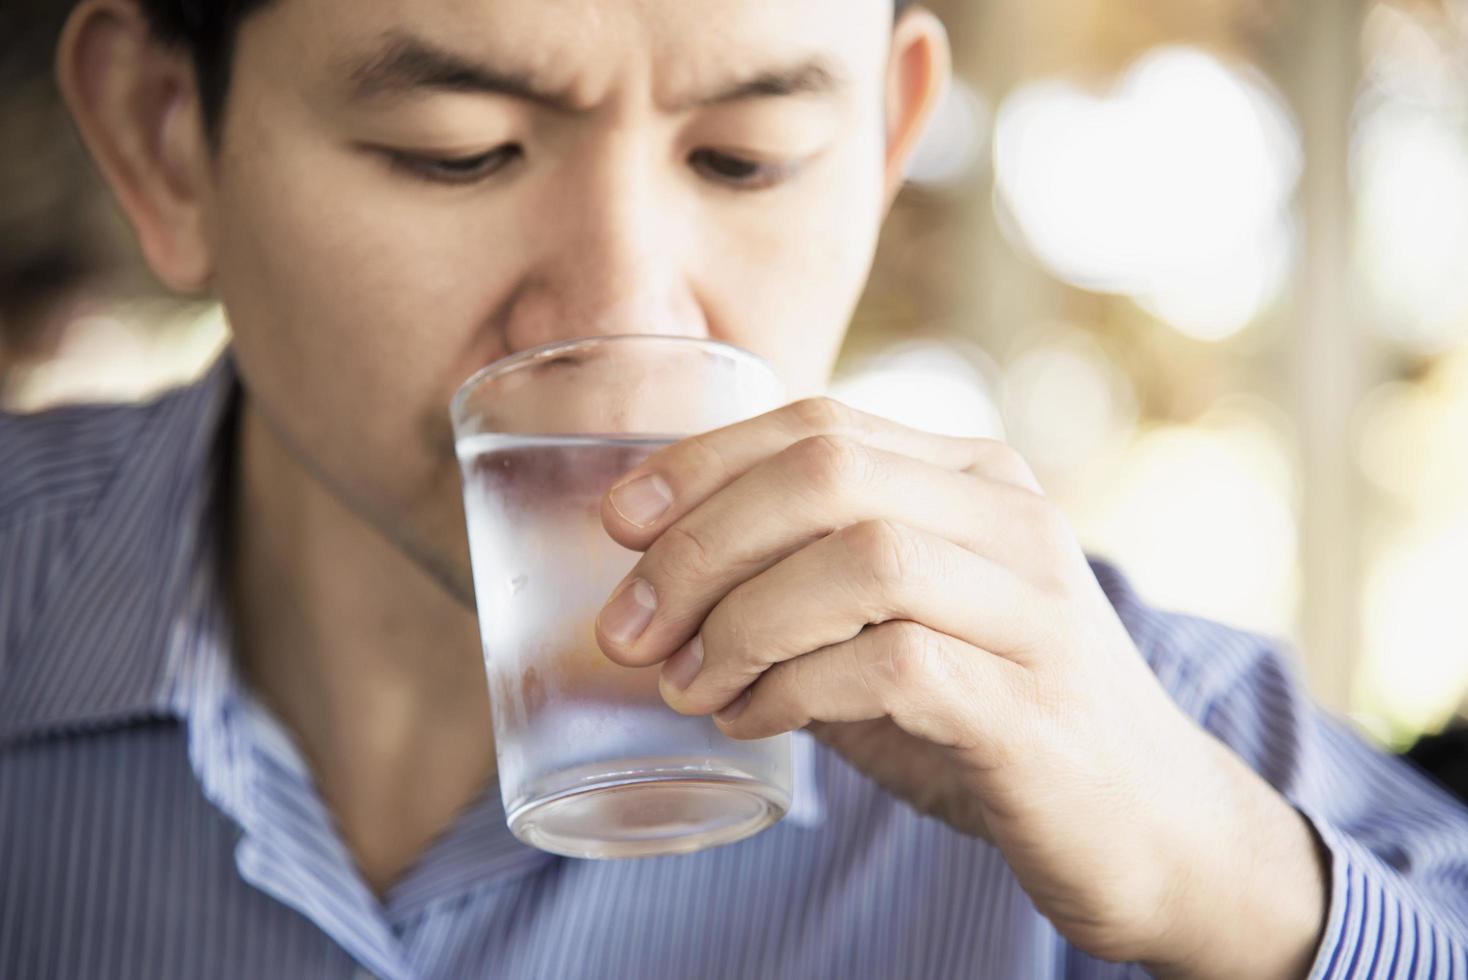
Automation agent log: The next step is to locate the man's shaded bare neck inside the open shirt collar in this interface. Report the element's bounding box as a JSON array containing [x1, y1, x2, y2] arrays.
[[228, 396, 495, 895]]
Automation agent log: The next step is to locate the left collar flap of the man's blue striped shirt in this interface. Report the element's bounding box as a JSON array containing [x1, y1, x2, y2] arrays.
[[0, 352, 238, 741]]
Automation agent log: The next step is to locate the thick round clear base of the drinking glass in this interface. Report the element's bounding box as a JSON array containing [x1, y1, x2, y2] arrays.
[[508, 764, 790, 858]]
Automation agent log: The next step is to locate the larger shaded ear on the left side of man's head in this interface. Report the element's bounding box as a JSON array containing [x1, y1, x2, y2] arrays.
[[56, 0, 213, 292]]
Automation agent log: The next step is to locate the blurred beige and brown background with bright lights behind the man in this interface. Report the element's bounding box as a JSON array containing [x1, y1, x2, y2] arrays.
[[0, 0, 1468, 748]]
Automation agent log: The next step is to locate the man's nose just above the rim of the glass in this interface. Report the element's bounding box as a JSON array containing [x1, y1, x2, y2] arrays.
[[505, 154, 709, 351]]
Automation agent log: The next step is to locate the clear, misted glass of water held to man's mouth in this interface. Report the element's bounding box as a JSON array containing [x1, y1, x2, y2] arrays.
[[452, 334, 791, 858]]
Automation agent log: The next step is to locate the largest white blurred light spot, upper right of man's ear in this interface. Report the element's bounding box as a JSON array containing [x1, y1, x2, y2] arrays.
[[994, 47, 1301, 339]]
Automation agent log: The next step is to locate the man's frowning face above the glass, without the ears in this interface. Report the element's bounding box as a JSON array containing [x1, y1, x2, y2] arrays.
[[207, 0, 891, 594]]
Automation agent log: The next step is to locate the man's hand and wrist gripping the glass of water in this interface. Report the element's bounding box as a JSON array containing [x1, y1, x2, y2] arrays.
[[597, 399, 1326, 977]]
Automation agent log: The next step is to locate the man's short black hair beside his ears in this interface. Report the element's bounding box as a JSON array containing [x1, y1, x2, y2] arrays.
[[139, 0, 913, 139]]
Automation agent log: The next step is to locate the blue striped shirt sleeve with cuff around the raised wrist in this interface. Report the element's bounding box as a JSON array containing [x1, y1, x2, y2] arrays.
[[1201, 628, 1468, 980]]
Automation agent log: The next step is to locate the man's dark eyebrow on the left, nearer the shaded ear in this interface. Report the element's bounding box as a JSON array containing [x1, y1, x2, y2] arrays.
[[346, 32, 573, 111]]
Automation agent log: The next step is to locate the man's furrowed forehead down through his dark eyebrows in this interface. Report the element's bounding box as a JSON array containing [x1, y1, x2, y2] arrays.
[[280, 0, 890, 107]]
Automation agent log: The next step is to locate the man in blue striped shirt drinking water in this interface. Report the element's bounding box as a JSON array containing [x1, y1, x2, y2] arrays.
[[0, 0, 1468, 977]]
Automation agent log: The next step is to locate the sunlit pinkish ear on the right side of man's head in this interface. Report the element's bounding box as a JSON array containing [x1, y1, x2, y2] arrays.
[[887, 7, 953, 207]]
